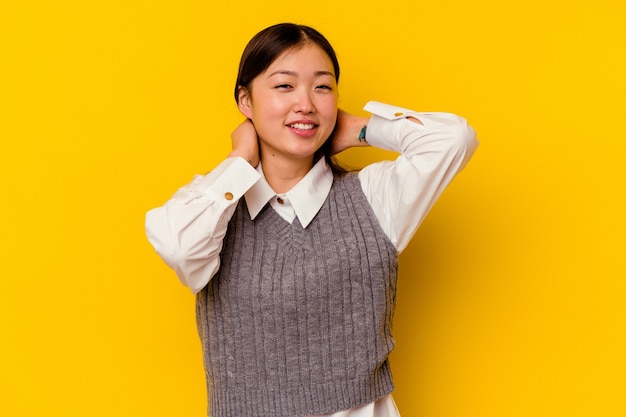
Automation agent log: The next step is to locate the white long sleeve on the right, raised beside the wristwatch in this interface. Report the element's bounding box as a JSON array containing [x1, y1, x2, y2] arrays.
[[359, 102, 478, 252]]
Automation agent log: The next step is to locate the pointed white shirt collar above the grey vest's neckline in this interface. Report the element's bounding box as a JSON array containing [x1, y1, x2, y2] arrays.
[[245, 158, 333, 228]]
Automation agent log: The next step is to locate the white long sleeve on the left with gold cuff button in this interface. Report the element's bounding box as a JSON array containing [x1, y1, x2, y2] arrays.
[[145, 157, 260, 294]]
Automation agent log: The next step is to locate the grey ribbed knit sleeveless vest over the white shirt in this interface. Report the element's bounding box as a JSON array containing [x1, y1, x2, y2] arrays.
[[196, 173, 397, 417]]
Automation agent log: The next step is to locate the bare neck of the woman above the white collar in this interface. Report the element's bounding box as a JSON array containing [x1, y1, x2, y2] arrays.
[[261, 156, 313, 194]]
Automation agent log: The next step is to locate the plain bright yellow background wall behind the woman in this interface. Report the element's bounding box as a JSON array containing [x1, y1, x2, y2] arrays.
[[0, 0, 626, 417]]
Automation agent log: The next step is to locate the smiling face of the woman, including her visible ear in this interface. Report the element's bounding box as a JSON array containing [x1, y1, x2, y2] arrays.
[[239, 43, 337, 163]]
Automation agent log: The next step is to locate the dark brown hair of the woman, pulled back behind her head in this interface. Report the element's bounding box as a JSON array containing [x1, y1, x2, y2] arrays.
[[235, 23, 346, 174]]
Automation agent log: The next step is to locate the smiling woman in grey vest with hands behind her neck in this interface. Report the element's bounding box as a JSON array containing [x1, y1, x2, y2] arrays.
[[146, 24, 477, 417]]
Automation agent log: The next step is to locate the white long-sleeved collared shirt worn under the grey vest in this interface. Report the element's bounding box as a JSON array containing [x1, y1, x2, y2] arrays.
[[146, 102, 478, 417]]
